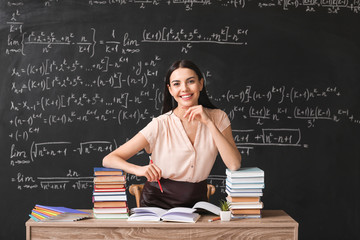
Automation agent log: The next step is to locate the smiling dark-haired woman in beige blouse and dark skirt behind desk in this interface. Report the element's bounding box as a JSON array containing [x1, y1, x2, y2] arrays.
[[103, 60, 241, 208]]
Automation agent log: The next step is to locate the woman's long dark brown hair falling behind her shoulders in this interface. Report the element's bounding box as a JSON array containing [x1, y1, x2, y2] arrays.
[[162, 60, 217, 114]]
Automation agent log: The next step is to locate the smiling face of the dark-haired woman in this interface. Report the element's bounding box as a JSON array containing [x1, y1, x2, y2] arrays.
[[168, 68, 204, 108]]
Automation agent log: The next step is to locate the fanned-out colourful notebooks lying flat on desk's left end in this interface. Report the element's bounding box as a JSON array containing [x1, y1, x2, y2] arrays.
[[29, 204, 91, 222]]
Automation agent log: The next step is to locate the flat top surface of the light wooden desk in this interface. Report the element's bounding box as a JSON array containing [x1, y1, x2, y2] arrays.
[[25, 210, 298, 228]]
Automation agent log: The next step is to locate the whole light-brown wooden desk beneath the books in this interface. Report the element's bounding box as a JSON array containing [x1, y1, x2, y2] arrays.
[[25, 210, 298, 240]]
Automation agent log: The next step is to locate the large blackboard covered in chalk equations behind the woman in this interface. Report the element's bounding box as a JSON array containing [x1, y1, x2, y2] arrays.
[[0, 0, 360, 239]]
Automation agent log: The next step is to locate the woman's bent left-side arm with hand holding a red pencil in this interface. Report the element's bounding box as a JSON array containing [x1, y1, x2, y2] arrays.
[[103, 133, 161, 181]]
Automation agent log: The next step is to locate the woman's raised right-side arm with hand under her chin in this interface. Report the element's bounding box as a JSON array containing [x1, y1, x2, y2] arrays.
[[184, 105, 241, 170]]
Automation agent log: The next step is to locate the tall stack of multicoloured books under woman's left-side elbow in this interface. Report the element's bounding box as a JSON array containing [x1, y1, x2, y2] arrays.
[[93, 167, 129, 218]]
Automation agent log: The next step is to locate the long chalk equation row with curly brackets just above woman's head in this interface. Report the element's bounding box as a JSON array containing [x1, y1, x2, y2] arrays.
[[5, 25, 249, 55]]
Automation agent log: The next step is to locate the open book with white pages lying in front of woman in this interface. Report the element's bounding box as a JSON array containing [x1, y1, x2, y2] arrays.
[[128, 201, 220, 223]]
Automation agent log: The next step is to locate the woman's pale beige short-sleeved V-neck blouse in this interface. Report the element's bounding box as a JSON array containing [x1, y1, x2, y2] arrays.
[[140, 109, 230, 182]]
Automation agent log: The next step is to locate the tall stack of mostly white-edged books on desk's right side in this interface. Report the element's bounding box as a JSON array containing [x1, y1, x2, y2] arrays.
[[225, 167, 265, 218]]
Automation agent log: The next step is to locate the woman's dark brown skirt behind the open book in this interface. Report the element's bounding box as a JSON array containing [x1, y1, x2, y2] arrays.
[[140, 178, 207, 209]]
